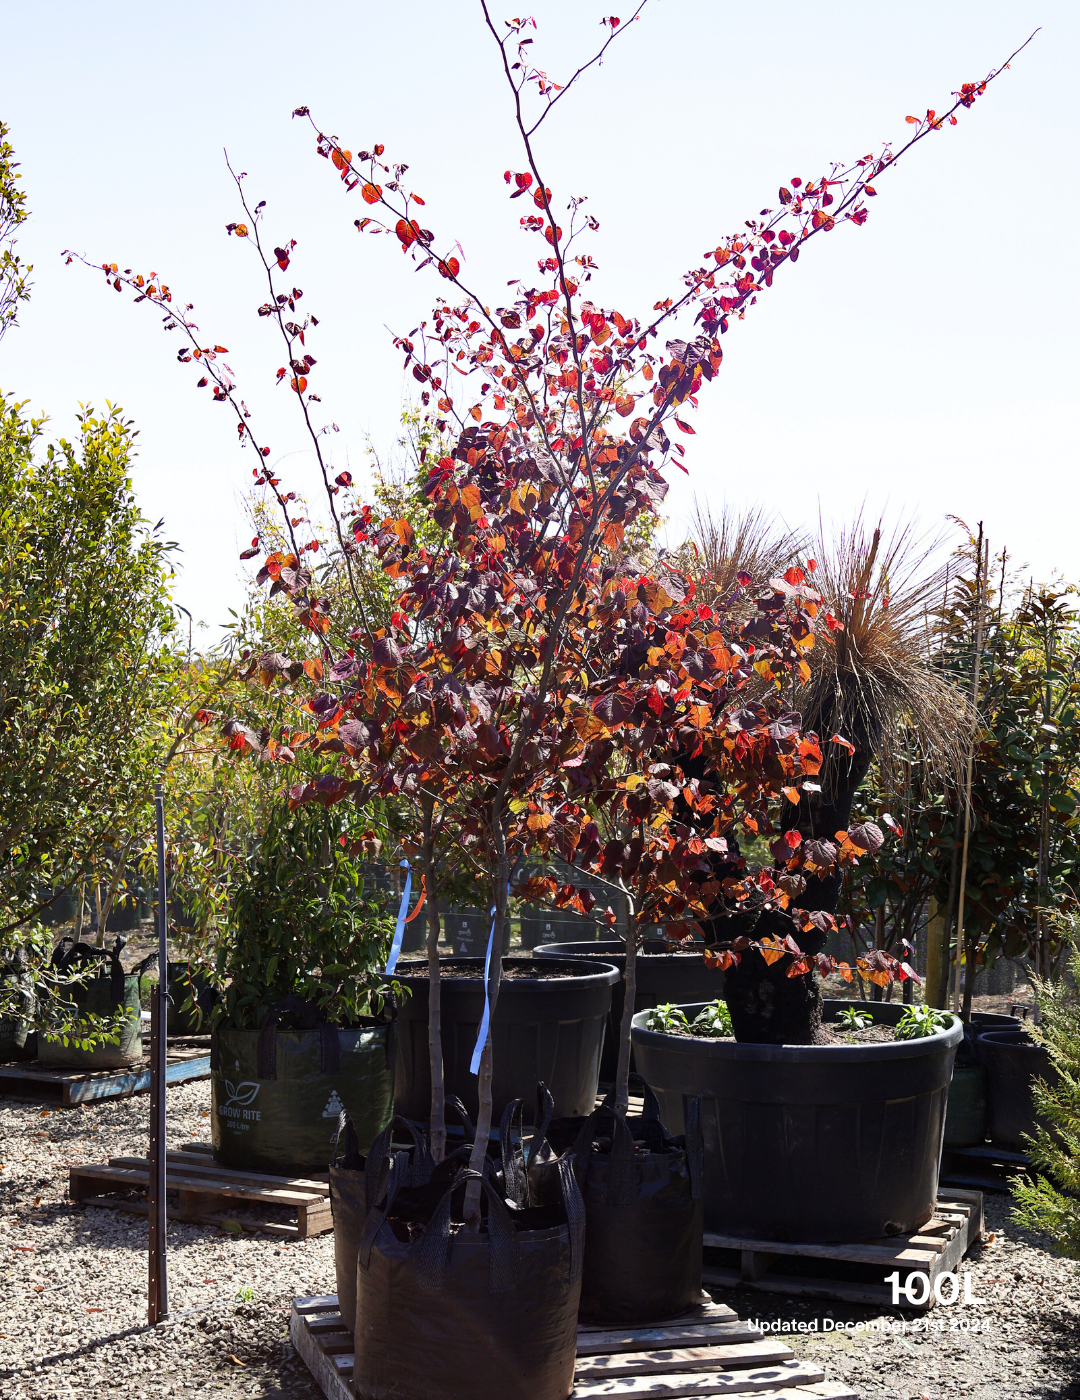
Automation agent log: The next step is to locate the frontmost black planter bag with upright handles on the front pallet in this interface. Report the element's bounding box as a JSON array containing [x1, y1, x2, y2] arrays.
[[353, 1158, 584, 1400]]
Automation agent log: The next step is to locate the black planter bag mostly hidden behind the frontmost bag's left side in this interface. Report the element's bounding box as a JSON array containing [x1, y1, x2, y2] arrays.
[[331, 1109, 434, 1331]]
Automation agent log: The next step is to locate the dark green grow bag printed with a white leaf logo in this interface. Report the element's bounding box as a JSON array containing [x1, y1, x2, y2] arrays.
[[210, 1016, 395, 1176]]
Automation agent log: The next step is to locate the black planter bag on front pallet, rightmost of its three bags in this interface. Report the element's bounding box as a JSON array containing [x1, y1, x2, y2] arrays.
[[526, 1074, 705, 1324]]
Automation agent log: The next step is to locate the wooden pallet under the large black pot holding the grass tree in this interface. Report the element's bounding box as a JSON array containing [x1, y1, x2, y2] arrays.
[[702, 1189, 982, 1312]]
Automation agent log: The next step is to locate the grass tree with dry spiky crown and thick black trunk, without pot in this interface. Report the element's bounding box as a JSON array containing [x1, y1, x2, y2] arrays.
[[714, 517, 971, 1044]]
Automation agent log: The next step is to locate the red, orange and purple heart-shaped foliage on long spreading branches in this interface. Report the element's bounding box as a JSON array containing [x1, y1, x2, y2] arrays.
[[69, 4, 1030, 1114]]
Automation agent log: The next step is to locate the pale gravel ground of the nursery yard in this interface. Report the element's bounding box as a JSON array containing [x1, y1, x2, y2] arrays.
[[0, 1081, 1080, 1400]]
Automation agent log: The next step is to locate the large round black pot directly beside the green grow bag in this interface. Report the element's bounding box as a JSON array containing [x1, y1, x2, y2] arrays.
[[394, 958, 619, 1121]]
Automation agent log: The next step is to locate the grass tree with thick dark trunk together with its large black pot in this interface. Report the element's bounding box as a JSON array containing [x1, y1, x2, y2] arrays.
[[633, 529, 980, 1240]]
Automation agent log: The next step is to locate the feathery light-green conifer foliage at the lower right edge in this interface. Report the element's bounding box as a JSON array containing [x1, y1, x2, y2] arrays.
[[1011, 935, 1080, 1259]]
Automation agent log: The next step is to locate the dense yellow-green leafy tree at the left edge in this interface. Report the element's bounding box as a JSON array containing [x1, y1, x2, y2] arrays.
[[0, 395, 176, 937]]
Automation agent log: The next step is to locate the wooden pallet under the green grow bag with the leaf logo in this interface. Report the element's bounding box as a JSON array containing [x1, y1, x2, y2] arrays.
[[69, 1142, 333, 1239]]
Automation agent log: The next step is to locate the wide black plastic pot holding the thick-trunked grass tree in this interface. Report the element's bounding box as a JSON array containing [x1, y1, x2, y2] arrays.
[[633, 1001, 964, 1243]]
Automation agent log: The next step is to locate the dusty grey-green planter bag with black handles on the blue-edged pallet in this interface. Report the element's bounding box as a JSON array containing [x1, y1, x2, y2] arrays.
[[38, 938, 143, 1070]]
